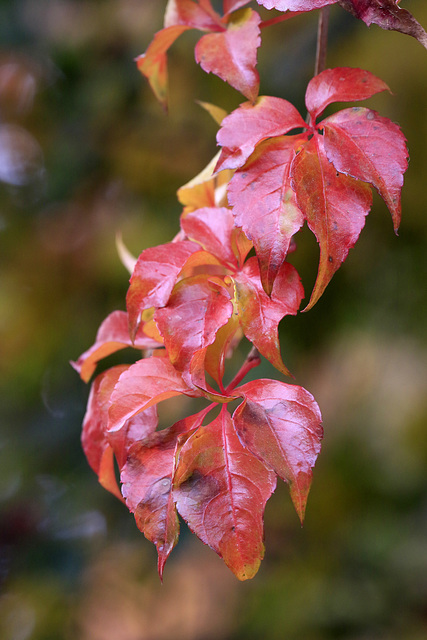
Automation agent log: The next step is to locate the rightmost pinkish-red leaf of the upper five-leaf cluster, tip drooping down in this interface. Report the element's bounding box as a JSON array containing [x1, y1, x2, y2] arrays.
[[322, 107, 408, 231]]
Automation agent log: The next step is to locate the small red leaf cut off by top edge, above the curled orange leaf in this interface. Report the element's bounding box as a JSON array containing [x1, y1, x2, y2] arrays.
[[164, 0, 221, 31]]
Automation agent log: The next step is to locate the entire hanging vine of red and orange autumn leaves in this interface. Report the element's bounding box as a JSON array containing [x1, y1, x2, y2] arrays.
[[73, 0, 427, 580]]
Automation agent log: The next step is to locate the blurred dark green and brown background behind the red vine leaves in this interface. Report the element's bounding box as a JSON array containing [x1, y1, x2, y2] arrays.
[[0, 0, 427, 640]]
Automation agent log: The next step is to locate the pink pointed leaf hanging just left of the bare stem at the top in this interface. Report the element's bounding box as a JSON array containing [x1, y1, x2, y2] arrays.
[[195, 9, 261, 102]]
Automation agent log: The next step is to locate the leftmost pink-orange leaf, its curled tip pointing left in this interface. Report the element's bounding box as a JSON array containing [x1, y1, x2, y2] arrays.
[[71, 311, 160, 382]]
